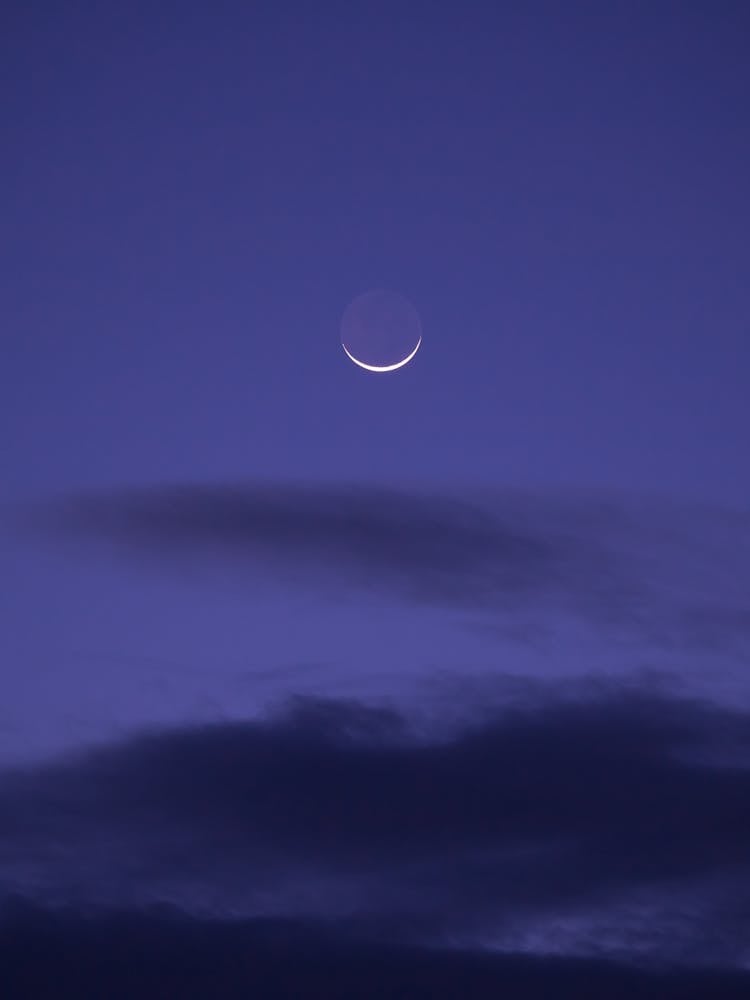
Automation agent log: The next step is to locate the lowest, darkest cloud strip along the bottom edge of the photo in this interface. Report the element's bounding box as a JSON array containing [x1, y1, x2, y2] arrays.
[[0, 904, 750, 1000]]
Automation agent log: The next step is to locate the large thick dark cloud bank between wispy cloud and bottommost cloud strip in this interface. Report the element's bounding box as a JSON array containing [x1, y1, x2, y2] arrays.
[[0, 691, 750, 965]]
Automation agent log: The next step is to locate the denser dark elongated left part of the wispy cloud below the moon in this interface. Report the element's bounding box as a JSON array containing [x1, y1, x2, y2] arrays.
[[35, 486, 562, 603]]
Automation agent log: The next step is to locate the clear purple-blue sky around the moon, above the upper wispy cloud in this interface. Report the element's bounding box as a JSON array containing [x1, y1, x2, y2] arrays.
[[2, 2, 750, 504]]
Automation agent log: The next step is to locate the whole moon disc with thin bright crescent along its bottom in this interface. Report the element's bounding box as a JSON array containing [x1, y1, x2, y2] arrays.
[[341, 289, 422, 374]]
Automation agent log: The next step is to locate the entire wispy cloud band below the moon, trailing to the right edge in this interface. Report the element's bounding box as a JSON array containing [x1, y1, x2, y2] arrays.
[[27, 485, 750, 652]]
